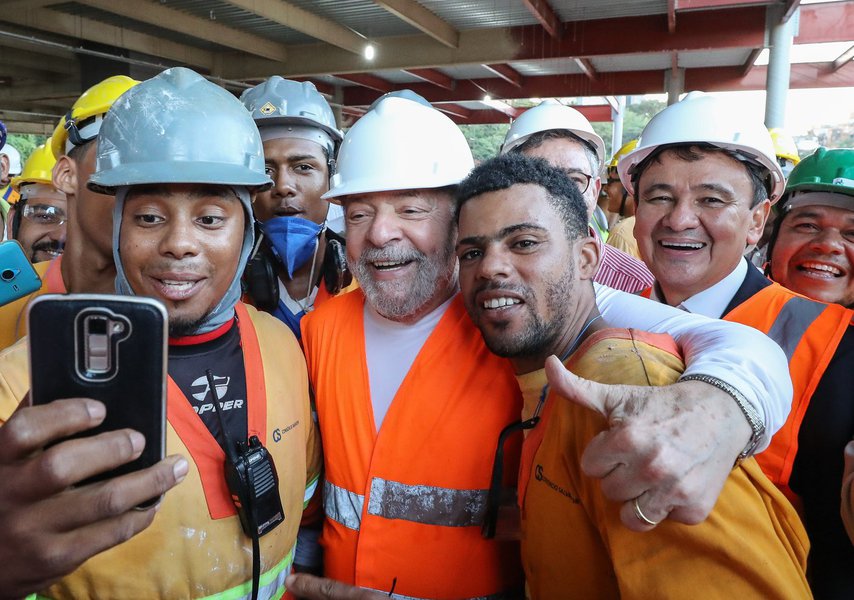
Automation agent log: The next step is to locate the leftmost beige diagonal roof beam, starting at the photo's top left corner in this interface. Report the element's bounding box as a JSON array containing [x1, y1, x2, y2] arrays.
[[0, 8, 214, 70]]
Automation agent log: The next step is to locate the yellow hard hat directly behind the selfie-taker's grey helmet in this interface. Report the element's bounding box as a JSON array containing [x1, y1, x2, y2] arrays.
[[50, 75, 139, 158]]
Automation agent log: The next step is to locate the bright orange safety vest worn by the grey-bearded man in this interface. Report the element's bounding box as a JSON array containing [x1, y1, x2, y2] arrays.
[[302, 290, 521, 599]]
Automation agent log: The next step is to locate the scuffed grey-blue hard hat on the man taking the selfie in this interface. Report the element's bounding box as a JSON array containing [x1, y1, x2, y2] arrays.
[[88, 67, 272, 194]]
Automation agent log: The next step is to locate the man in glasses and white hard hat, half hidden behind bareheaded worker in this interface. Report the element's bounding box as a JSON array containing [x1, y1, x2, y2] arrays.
[[501, 100, 653, 292]]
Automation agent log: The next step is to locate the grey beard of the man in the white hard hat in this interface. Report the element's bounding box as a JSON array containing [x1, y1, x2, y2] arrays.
[[348, 232, 456, 321]]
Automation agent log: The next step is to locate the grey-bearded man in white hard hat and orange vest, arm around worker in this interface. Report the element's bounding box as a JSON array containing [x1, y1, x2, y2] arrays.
[[288, 97, 790, 598]]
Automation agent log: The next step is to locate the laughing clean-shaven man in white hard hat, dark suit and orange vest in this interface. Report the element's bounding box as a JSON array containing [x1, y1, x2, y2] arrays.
[[618, 92, 854, 598]]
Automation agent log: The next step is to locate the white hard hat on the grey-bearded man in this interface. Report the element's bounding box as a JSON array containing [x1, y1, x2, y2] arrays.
[[323, 97, 474, 203]]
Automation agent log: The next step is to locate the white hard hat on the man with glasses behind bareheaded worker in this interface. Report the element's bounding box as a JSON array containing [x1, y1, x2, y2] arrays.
[[501, 100, 605, 172]]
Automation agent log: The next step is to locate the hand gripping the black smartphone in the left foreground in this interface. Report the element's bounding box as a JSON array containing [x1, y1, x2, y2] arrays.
[[0, 398, 188, 598]]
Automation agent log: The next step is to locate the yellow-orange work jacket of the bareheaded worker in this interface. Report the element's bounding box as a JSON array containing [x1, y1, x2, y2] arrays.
[[518, 329, 810, 600]]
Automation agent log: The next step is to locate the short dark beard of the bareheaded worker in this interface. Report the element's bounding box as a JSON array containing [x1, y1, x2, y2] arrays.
[[469, 270, 575, 358]]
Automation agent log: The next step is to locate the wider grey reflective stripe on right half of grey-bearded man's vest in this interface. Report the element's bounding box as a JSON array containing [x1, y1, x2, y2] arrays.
[[368, 477, 487, 527]]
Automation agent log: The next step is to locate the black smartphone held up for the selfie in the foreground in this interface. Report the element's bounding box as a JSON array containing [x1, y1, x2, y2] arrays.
[[27, 294, 168, 505]]
